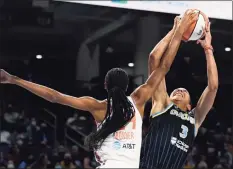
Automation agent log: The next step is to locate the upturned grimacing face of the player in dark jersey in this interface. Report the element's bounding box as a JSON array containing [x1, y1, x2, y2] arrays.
[[170, 88, 190, 104]]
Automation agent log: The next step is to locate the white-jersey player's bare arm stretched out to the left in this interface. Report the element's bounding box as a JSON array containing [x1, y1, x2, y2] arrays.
[[0, 69, 103, 119]]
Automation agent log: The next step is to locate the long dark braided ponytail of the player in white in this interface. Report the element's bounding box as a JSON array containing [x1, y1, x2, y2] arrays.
[[85, 68, 134, 149]]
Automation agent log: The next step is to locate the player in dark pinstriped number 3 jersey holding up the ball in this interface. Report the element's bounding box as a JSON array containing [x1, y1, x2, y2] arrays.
[[140, 14, 218, 169]]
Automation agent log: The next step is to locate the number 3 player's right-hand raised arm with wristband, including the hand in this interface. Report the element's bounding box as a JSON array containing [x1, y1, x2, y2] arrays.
[[195, 24, 218, 128]]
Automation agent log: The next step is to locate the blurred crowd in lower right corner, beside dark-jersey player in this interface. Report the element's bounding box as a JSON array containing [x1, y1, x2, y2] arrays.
[[185, 123, 233, 169]]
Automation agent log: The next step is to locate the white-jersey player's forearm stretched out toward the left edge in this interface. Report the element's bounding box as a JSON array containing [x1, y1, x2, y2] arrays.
[[11, 76, 60, 102]]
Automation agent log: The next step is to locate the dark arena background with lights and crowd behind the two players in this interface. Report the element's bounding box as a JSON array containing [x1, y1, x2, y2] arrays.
[[0, 0, 233, 168]]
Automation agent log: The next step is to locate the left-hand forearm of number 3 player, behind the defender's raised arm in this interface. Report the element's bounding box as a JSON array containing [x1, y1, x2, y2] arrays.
[[149, 29, 175, 73]]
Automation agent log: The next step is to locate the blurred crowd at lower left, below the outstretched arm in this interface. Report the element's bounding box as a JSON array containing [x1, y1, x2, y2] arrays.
[[0, 104, 97, 169]]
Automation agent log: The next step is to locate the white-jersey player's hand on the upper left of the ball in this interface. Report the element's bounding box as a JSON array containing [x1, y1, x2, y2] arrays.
[[180, 9, 198, 34]]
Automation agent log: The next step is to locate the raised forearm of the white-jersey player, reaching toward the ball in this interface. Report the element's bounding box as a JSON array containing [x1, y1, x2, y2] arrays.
[[160, 27, 183, 70]]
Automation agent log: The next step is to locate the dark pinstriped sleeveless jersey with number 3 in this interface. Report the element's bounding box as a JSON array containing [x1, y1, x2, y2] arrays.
[[140, 104, 195, 169]]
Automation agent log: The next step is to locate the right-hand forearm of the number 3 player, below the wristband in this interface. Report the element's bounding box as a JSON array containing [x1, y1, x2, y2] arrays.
[[205, 49, 218, 90]]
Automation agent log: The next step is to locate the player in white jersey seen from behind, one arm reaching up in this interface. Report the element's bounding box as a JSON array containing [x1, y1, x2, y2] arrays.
[[0, 13, 186, 168]]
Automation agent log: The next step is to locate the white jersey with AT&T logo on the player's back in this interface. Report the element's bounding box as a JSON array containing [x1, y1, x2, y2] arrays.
[[94, 97, 142, 168]]
